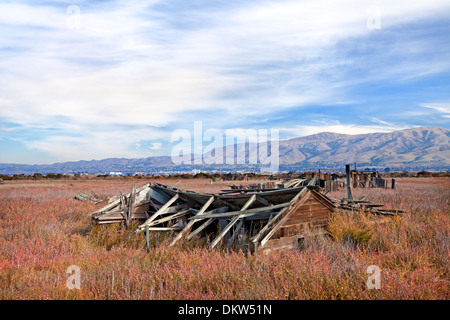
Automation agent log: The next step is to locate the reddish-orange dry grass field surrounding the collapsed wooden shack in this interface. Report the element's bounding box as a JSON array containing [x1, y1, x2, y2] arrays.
[[0, 178, 450, 300]]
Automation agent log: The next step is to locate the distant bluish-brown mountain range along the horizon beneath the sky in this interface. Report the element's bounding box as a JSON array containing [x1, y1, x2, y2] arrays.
[[0, 127, 450, 174]]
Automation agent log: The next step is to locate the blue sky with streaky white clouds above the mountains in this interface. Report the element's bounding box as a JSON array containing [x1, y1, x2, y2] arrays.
[[0, 0, 450, 164]]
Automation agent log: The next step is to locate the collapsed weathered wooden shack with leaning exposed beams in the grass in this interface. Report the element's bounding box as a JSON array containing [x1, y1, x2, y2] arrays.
[[90, 178, 400, 252]]
